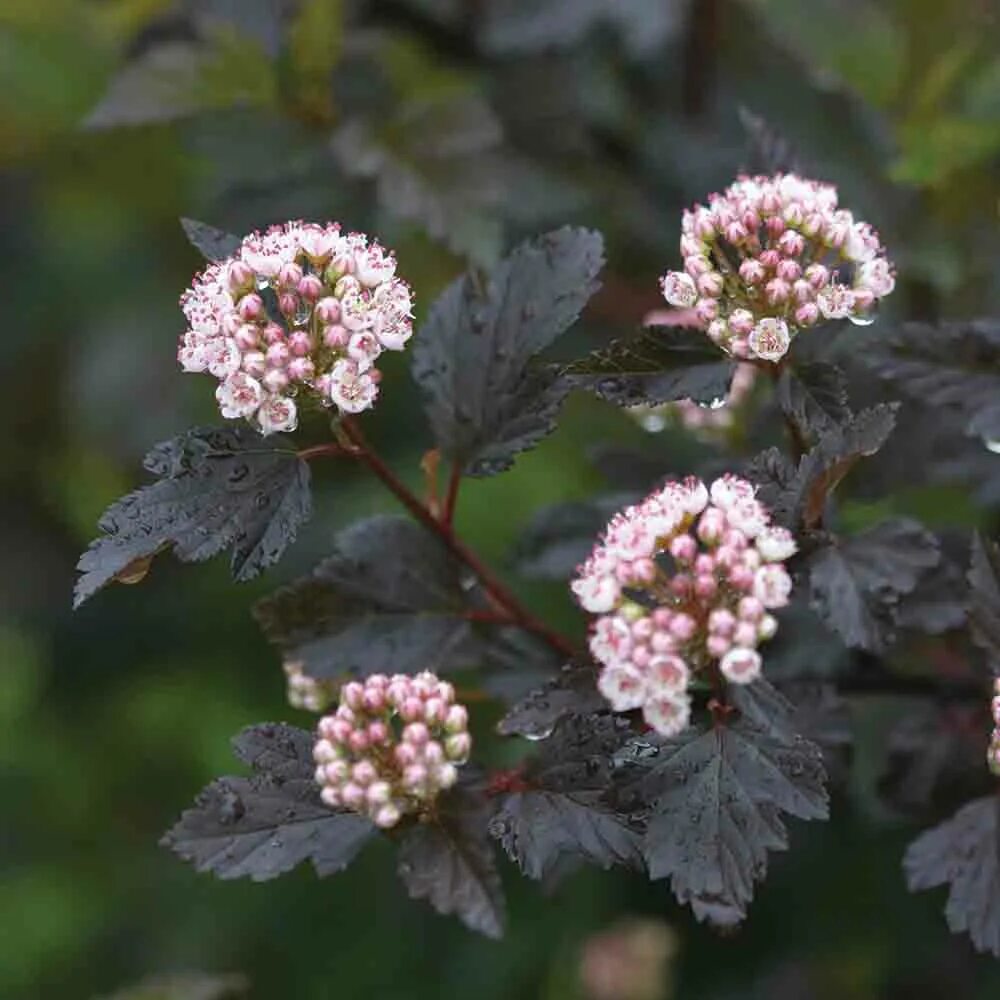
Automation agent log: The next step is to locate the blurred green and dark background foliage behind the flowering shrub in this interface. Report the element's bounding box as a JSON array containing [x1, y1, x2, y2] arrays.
[[0, 0, 1000, 1000]]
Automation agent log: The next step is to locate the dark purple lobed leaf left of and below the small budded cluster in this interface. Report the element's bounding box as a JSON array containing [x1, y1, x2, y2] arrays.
[[161, 723, 375, 882]]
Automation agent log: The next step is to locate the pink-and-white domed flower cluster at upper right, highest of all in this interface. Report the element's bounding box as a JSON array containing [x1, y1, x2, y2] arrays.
[[660, 174, 895, 361]]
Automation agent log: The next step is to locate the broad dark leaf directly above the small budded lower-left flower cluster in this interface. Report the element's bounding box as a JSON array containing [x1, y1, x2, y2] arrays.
[[254, 516, 496, 678]]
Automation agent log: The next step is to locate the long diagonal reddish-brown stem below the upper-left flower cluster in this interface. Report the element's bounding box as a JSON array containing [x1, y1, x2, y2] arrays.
[[334, 418, 576, 656]]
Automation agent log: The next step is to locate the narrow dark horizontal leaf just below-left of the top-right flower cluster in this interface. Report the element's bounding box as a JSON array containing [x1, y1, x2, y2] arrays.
[[563, 327, 736, 406]]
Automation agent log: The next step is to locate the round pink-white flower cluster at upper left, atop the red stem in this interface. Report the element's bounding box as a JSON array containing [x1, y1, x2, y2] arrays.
[[177, 222, 413, 434]]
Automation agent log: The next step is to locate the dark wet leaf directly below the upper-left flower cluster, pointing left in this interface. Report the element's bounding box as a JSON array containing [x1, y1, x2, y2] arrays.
[[74, 425, 311, 607]]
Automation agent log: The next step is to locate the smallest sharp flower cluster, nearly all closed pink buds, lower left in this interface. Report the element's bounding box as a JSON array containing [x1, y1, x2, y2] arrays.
[[313, 673, 472, 828]]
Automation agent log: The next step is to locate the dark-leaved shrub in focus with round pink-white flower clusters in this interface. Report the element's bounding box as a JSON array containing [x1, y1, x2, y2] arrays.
[[76, 156, 1000, 955]]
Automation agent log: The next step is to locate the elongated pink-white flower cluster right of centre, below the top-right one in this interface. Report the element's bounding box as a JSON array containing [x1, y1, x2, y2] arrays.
[[572, 475, 796, 736]]
